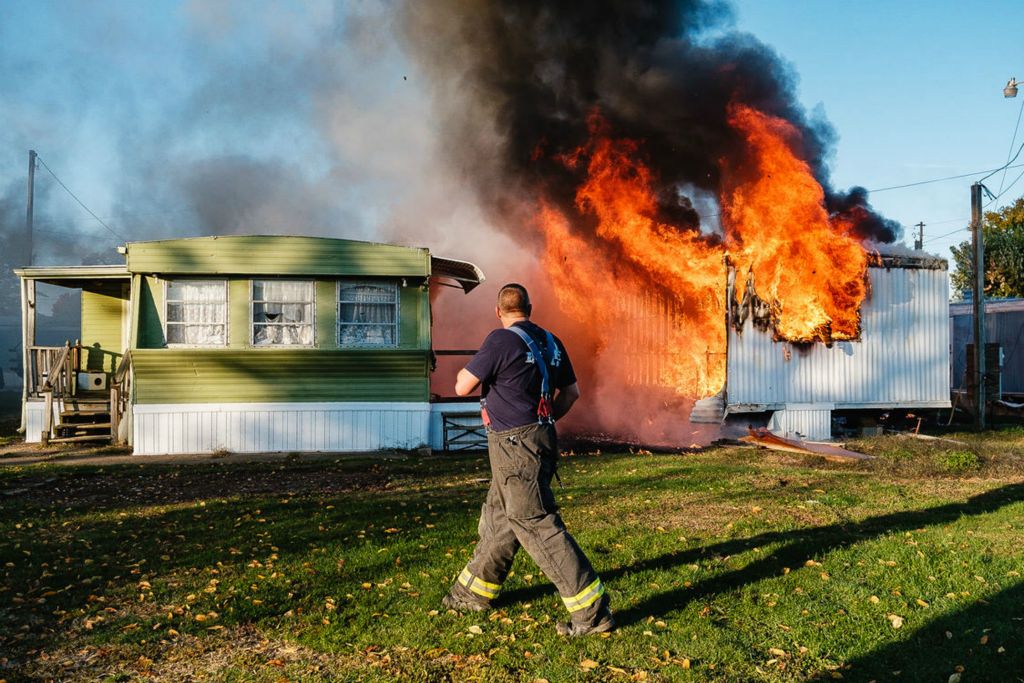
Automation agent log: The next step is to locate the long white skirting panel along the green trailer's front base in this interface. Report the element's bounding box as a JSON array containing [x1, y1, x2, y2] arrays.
[[132, 402, 431, 455]]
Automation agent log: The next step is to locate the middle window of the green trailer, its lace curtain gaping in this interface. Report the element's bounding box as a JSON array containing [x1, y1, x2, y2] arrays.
[[253, 280, 313, 346]]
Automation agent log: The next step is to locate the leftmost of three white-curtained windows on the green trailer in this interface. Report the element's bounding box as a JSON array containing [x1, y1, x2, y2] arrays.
[[167, 281, 227, 346]]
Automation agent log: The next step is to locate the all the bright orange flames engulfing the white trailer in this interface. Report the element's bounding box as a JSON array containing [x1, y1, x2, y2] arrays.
[[537, 104, 867, 396]]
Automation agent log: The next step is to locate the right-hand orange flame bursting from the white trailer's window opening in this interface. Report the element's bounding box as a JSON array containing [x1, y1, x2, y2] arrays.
[[721, 104, 867, 342]]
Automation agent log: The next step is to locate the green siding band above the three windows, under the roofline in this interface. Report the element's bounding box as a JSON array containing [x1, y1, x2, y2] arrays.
[[128, 236, 430, 278]]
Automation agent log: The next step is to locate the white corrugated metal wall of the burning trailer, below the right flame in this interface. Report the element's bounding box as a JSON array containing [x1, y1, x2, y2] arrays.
[[726, 267, 949, 412]]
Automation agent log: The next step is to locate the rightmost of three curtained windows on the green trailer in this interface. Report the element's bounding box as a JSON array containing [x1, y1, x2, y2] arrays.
[[338, 283, 398, 346]]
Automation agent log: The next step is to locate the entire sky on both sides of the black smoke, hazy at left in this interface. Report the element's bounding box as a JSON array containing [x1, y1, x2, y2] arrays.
[[0, 0, 1024, 272]]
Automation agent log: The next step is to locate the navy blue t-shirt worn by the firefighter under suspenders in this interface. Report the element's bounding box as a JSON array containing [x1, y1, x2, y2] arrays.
[[466, 321, 577, 431]]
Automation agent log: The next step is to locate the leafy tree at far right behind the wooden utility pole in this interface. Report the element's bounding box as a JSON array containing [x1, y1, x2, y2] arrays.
[[950, 197, 1024, 299]]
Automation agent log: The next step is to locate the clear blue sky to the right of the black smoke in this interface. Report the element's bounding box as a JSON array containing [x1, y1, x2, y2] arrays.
[[736, 0, 1024, 257]]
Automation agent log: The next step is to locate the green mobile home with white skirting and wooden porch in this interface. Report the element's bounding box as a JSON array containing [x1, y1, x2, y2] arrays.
[[17, 236, 483, 455]]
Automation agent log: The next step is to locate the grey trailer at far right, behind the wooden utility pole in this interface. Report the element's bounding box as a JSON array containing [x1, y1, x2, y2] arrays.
[[949, 299, 1024, 399]]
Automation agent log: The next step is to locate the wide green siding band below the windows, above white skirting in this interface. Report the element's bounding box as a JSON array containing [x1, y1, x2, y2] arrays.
[[132, 349, 429, 403]]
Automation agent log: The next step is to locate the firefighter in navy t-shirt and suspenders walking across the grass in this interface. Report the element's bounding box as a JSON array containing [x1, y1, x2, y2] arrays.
[[441, 284, 614, 637]]
